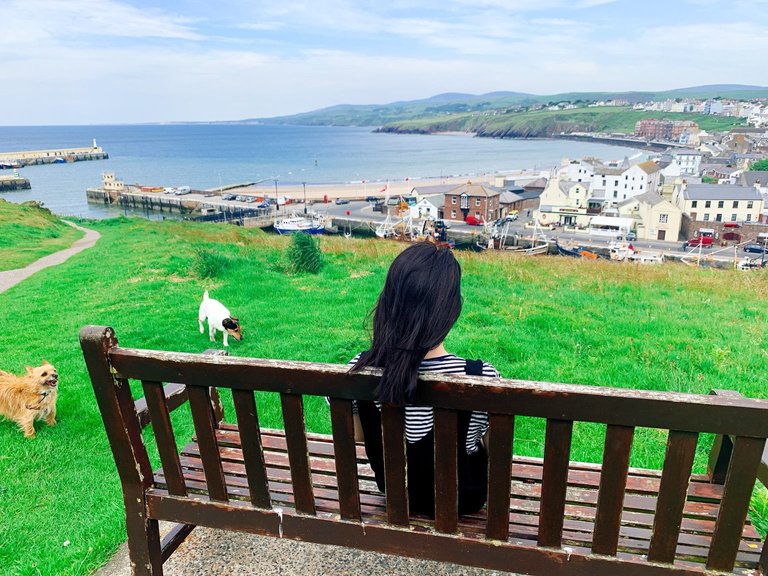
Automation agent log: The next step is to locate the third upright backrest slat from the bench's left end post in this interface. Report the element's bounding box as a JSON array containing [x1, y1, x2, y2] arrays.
[[232, 388, 271, 508]]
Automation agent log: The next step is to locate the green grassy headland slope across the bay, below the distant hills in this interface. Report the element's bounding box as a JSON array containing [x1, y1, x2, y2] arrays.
[[387, 106, 745, 137]]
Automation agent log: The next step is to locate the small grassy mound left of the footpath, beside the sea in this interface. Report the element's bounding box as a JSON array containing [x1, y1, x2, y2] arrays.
[[0, 198, 83, 271]]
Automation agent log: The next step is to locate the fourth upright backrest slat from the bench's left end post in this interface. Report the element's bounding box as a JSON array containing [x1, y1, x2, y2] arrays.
[[280, 393, 317, 515]]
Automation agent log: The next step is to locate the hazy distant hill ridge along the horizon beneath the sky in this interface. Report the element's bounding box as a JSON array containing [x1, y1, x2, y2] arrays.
[[248, 84, 768, 126]]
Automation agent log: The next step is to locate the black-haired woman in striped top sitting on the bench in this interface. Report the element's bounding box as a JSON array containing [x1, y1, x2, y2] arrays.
[[350, 242, 499, 516]]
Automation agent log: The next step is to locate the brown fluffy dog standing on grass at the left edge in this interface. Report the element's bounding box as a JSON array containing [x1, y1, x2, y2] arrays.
[[0, 360, 59, 438]]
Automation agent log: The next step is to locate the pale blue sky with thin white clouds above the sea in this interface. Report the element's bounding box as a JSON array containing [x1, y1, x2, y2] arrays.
[[0, 0, 768, 126]]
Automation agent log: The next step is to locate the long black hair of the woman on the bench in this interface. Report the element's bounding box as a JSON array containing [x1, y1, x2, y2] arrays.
[[351, 242, 462, 404]]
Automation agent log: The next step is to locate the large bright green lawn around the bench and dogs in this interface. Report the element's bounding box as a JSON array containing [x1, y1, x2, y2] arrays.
[[0, 209, 768, 575]]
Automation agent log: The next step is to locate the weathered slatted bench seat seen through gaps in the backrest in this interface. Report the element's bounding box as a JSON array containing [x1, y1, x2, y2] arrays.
[[149, 423, 762, 574]]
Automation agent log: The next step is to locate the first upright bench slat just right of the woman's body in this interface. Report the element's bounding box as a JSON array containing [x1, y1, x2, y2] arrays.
[[486, 414, 515, 540]]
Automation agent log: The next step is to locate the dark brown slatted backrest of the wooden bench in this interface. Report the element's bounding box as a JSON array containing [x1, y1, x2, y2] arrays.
[[80, 327, 768, 570]]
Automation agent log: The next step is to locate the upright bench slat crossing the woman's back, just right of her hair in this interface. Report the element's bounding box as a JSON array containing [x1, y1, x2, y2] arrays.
[[434, 408, 456, 534]]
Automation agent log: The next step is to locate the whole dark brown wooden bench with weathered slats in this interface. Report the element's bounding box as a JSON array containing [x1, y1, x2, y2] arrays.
[[80, 326, 768, 576]]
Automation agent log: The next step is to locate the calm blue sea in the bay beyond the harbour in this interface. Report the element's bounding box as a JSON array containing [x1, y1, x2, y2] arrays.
[[0, 124, 638, 218]]
